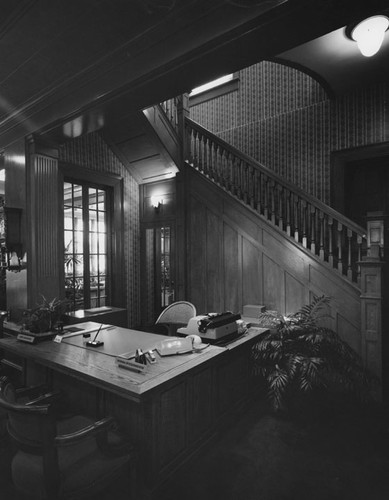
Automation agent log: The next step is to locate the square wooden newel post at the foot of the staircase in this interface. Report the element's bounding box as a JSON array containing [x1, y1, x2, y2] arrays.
[[359, 213, 385, 380]]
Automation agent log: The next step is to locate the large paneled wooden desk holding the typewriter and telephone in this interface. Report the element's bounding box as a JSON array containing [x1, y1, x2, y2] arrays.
[[0, 322, 264, 498]]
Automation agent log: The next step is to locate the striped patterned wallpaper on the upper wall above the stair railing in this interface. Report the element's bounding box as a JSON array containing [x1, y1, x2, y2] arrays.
[[190, 61, 389, 203]]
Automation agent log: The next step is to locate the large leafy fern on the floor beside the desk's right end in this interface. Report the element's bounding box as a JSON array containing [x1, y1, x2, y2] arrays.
[[252, 295, 375, 411]]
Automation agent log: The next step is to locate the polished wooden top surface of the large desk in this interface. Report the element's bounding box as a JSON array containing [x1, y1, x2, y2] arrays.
[[0, 321, 265, 400]]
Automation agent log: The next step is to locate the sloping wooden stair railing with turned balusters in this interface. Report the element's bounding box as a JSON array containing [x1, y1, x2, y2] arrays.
[[185, 118, 367, 284]]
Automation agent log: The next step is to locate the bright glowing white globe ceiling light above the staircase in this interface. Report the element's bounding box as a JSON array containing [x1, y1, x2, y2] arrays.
[[346, 15, 389, 57]]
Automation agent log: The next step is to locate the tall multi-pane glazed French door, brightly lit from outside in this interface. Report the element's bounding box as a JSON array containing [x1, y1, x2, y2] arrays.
[[64, 181, 110, 310]]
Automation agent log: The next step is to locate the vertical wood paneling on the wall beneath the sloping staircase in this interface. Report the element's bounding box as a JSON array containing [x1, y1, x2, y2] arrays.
[[186, 167, 361, 352]]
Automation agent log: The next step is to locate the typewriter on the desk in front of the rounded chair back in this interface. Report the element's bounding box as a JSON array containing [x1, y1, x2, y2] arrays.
[[178, 311, 241, 340]]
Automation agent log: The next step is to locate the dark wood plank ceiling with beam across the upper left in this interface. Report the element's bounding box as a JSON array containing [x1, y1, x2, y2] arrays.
[[0, 0, 387, 182]]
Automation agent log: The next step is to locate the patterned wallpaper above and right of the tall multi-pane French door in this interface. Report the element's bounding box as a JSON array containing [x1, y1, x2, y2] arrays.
[[60, 132, 140, 327]]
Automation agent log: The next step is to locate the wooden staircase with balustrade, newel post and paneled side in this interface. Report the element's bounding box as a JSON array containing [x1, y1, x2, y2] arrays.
[[142, 98, 382, 373]]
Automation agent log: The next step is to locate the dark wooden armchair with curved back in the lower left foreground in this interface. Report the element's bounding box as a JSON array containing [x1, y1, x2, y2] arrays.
[[0, 376, 136, 500]]
